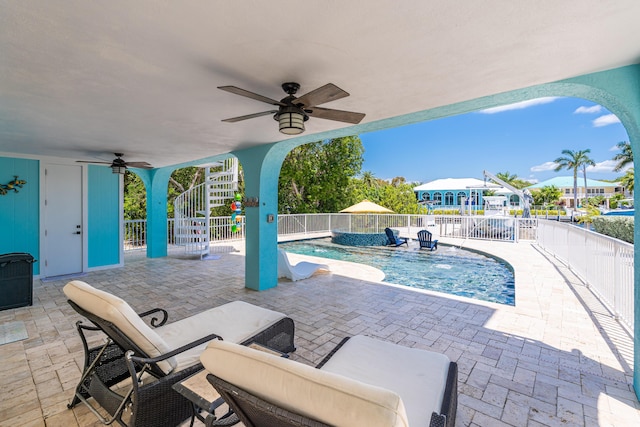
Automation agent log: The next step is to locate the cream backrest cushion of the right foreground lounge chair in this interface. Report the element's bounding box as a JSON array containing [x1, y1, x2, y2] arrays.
[[200, 341, 410, 427]]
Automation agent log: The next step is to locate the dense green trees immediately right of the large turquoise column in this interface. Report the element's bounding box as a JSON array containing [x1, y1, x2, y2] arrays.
[[278, 136, 364, 213]]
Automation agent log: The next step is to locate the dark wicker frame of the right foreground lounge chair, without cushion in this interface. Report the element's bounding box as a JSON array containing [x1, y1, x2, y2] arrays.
[[207, 337, 458, 427]]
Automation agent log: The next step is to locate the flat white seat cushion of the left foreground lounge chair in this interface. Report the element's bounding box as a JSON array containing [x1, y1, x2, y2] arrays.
[[156, 301, 286, 371]]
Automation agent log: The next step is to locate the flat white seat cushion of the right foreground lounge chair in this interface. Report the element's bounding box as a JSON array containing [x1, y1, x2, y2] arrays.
[[322, 335, 451, 426]]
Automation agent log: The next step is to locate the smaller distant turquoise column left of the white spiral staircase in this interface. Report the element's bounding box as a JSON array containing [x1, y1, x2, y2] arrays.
[[135, 168, 172, 258]]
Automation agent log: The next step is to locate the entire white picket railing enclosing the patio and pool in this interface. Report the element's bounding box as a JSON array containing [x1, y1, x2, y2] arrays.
[[124, 214, 634, 334]]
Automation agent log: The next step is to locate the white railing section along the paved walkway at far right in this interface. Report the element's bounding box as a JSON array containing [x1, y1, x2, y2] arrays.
[[538, 221, 634, 334]]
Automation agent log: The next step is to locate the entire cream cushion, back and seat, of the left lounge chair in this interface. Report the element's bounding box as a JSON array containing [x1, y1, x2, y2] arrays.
[[63, 280, 286, 374]]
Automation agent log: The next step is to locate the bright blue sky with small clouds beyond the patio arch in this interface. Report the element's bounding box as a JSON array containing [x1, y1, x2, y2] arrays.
[[360, 98, 629, 183]]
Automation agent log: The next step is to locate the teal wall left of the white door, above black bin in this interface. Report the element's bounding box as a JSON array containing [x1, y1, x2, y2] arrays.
[[0, 157, 40, 275]]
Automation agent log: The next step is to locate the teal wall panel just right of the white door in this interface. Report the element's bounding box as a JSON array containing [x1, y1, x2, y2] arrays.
[[87, 165, 122, 268]]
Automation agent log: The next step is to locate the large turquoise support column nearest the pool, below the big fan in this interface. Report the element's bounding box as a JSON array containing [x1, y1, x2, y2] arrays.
[[233, 143, 290, 291]]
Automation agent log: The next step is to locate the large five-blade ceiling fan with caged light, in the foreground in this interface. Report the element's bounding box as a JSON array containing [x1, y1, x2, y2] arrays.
[[218, 82, 365, 135]]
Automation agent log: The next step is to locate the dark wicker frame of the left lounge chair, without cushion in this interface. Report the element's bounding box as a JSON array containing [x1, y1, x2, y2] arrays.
[[67, 300, 295, 427]]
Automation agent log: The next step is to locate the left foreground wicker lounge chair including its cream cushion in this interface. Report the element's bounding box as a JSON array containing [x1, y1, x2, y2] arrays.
[[63, 280, 295, 427]]
